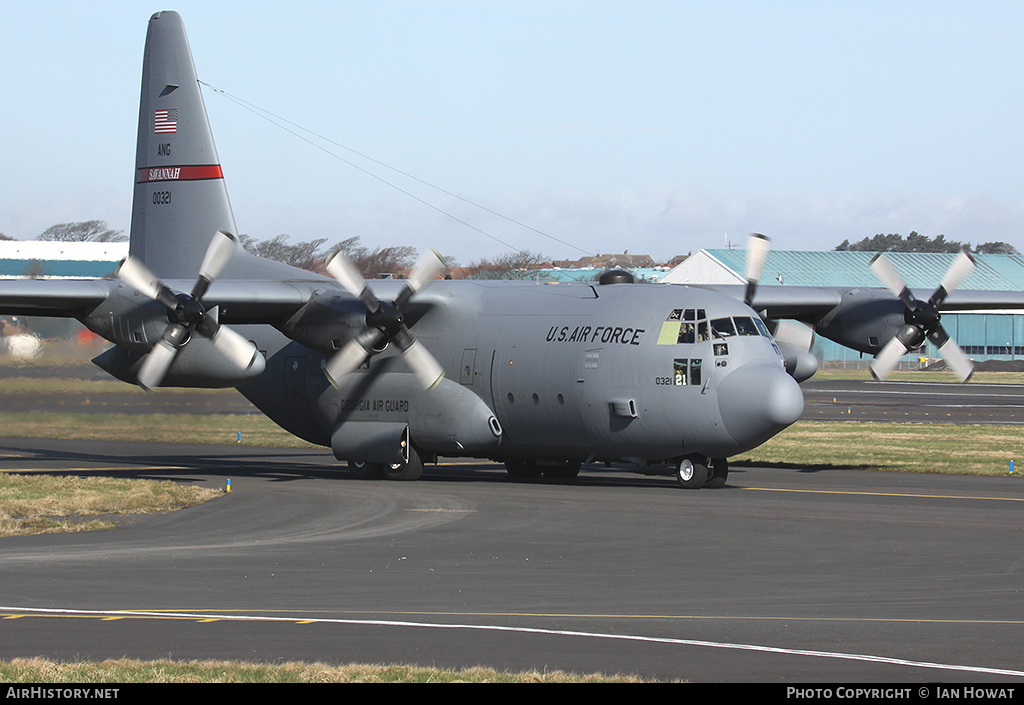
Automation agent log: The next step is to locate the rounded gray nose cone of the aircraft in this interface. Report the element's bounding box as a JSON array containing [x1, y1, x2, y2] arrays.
[[718, 363, 804, 449]]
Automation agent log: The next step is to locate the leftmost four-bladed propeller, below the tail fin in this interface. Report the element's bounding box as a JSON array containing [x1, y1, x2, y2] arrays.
[[116, 231, 259, 389]]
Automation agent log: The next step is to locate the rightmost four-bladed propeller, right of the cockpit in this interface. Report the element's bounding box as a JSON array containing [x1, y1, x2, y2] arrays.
[[870, 251, 975, 382]]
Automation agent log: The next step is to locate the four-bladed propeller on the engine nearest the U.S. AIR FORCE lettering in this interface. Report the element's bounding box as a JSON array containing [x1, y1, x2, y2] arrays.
[[324, 250, 444, 389]]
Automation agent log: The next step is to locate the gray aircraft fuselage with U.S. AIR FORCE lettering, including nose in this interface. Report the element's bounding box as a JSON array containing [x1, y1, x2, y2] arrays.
[[240, 281, 803, 461]]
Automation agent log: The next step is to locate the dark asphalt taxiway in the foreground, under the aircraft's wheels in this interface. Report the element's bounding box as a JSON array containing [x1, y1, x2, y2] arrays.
[[0, 439, 1024, 682]]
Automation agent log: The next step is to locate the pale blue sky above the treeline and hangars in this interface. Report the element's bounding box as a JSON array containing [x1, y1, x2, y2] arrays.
[[0, 0, 1024, 263]]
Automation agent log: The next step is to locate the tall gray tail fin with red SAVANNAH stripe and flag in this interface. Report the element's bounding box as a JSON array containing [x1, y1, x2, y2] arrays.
[[130, 11, 238, 279]]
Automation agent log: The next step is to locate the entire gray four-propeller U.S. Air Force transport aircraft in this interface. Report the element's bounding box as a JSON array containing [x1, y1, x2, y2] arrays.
[[0, 11, 1024, 489]]
